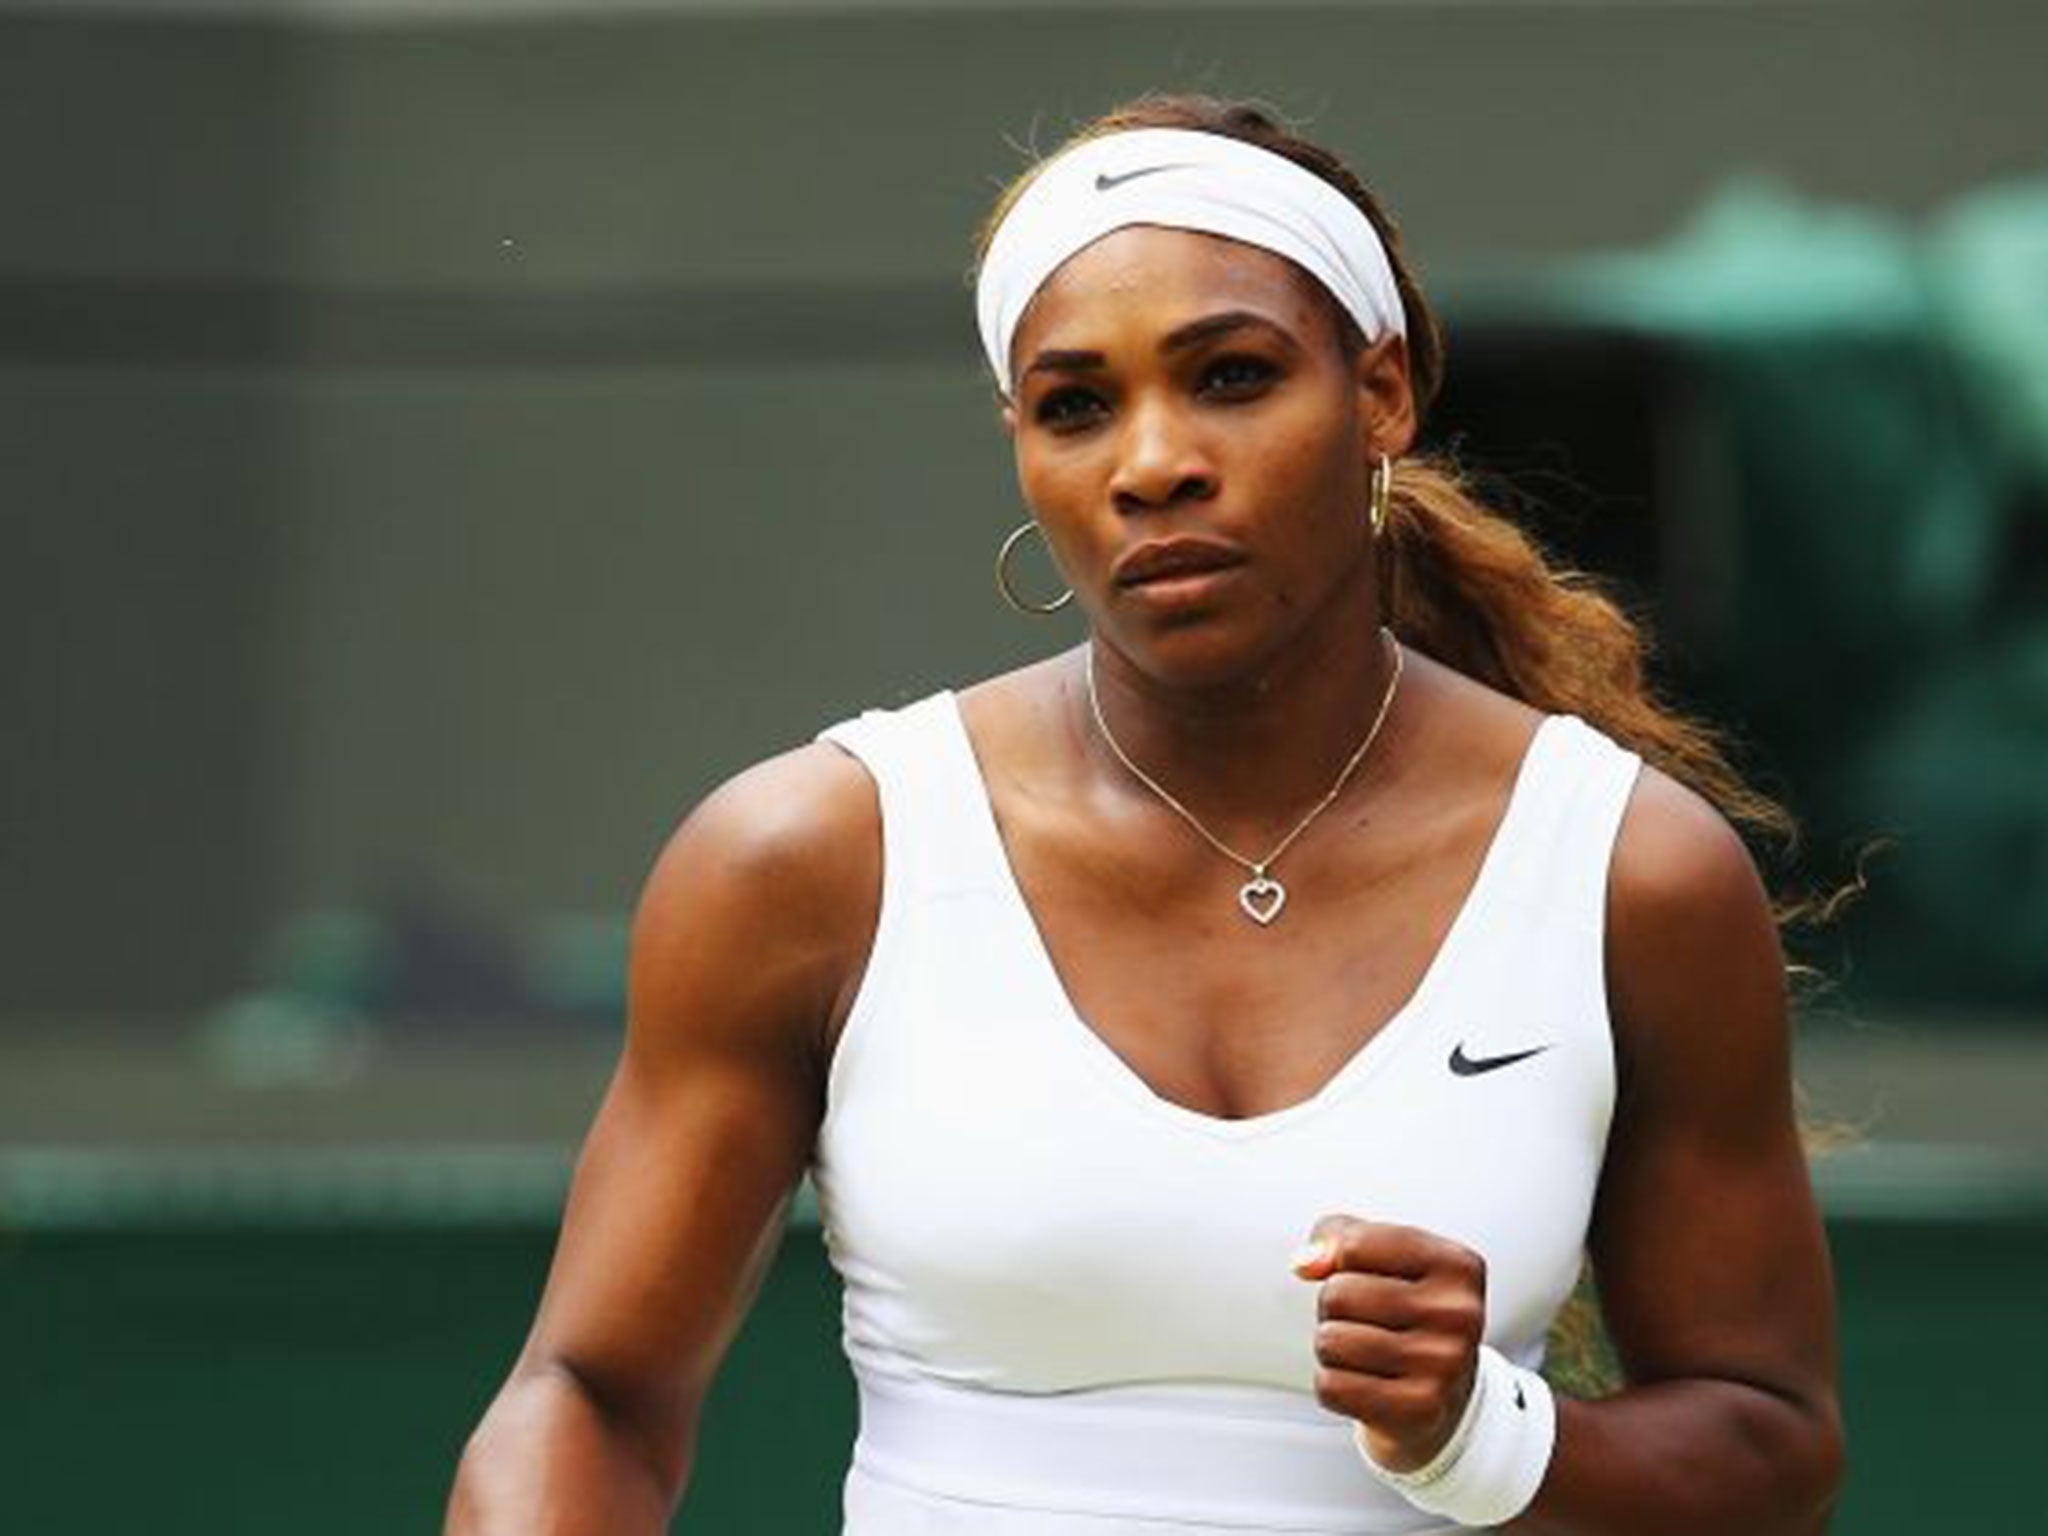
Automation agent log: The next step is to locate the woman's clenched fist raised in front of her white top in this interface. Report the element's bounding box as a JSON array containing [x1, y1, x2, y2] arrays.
[[1294, 1217, 1487, 1473]]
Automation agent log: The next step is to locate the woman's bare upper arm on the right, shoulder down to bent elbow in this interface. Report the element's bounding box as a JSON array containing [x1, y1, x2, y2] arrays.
[[1591, 772, 1835, 1413]]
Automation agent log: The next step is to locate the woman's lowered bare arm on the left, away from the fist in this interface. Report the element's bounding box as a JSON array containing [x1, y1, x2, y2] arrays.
[[446, 745, 881, 1536]]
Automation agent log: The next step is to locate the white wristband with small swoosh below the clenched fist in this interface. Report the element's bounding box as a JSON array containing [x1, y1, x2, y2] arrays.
[[1354, 1343, 1556, 1528]]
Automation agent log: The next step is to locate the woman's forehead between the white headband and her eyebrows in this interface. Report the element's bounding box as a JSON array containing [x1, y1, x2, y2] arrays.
[[1012, 223, 1319, 356]]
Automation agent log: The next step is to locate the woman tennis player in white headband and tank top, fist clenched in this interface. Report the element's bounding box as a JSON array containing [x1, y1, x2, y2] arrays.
[[449, 98, 1843, 1536]]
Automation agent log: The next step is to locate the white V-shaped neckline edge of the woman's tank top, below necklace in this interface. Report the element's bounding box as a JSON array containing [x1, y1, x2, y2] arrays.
[[942, 690, 1565, 1141]]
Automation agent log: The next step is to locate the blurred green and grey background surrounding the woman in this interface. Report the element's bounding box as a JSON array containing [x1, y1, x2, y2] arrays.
[[0, 0, 2048, 1536]]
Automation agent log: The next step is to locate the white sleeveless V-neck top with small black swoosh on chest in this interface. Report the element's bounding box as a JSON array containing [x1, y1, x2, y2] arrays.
[[813, 692, 1638, 1536]]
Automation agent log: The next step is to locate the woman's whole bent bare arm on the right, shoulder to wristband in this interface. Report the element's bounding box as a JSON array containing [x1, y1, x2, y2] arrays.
[[1511, 768, 1843, 1536]]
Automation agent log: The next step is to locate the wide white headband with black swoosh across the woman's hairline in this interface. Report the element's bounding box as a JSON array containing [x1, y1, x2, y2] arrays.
[[975, 129, 1407, 395]]
